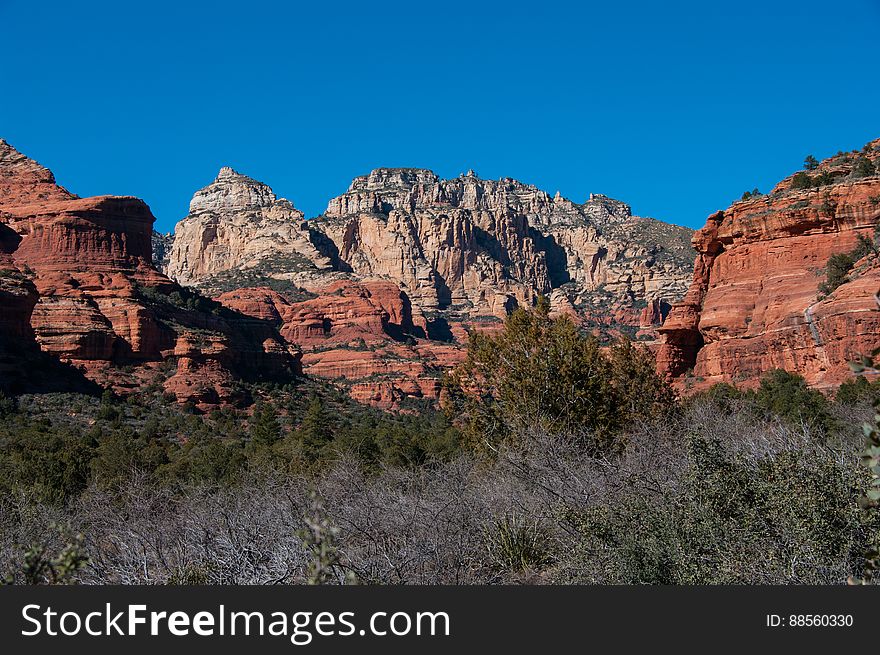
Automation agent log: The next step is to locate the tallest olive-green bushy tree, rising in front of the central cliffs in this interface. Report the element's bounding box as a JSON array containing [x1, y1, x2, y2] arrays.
[[445, 301, 675, 454]]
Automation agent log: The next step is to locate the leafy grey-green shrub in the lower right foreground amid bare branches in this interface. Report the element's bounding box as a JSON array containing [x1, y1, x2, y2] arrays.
[[559, 436, 870, 584]]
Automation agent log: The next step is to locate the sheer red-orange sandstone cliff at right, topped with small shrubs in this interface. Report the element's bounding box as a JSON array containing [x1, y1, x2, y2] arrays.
[[657, 141, 880, 388]]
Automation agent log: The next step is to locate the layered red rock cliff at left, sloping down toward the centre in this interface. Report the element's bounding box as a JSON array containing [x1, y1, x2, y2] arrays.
[[0, 142, 299, 403]]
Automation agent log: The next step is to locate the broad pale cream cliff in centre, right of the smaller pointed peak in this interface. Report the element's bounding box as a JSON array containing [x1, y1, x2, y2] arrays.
[[312, 169, 692, 325]]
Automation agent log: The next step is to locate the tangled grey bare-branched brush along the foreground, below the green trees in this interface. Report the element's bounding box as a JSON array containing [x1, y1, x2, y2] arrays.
[[0, 398, 876, 584]]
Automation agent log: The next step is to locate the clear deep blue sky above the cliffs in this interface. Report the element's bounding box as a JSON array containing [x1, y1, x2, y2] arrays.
[[0, 0, 880, 231]]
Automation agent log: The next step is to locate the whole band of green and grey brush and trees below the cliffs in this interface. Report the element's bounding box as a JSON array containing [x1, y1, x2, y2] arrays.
[[0, 305, 880, 584]]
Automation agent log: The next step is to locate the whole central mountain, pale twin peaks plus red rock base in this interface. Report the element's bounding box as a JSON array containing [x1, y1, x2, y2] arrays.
[[166, 168, 693, 408]]
